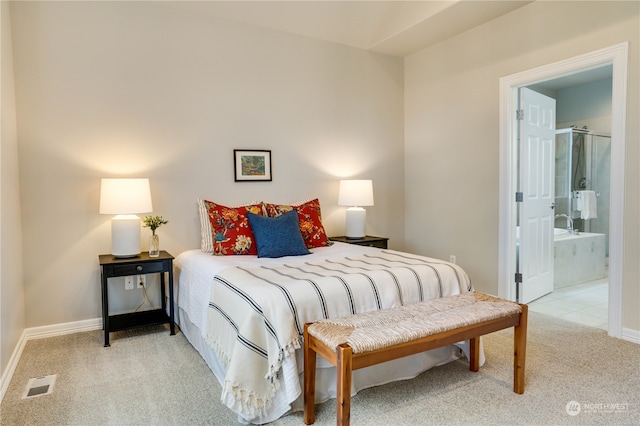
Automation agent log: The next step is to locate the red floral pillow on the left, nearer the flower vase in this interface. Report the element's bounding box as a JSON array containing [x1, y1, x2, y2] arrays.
[[204, 200, 262, 256]]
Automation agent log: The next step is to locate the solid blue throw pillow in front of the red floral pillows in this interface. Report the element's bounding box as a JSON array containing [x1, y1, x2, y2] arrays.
[[247, 210, 311, 257]]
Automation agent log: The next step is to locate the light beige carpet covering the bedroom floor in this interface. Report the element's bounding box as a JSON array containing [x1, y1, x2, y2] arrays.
[[0, 312, 640, 425]]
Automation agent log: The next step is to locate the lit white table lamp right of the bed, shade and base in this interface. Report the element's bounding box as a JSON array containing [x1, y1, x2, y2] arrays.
[[338, 179, 373, 238]]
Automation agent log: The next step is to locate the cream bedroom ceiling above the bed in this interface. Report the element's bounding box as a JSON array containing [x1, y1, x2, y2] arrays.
[[162, 0, 531, 57]]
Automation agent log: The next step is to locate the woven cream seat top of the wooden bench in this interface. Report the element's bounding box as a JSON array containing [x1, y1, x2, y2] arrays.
[[308, 291, 522, 353]]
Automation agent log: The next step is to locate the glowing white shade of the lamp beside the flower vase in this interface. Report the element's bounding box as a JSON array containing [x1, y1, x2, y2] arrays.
[[100, 178, 153, 214]]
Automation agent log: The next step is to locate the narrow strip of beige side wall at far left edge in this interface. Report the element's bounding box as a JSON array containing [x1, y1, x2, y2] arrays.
[[0, 1, 25, 380]]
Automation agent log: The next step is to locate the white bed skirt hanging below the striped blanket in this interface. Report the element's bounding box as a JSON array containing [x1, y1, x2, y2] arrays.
[[178, 308, 484, 424]]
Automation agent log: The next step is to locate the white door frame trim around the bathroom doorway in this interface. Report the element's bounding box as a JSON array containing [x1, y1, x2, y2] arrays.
[[498, 43, 628, 337]]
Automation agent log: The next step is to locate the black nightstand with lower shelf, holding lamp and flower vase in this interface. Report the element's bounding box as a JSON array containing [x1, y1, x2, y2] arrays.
[[98, 250, 176, 347]]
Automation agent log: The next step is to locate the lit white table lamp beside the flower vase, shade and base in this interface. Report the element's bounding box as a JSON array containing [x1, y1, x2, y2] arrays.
[[100, 179, 153, 257]]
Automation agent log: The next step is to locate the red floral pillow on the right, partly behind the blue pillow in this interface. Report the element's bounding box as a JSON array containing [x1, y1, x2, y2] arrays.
[[263, 198, 333, 248]]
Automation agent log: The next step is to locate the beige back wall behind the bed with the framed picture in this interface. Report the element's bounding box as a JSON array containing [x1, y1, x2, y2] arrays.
[[12, 2, 404, 327]]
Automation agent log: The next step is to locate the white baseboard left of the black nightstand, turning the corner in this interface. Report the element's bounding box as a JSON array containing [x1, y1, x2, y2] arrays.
[[0, 318, 102, 402]]
